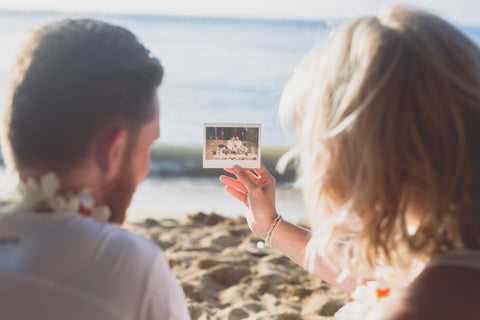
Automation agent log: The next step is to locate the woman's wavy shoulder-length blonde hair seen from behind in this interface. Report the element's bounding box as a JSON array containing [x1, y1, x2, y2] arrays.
[[280, 7, 480, 276]]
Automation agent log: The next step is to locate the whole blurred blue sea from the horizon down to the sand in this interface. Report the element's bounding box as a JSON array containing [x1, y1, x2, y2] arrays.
[[0, 11, 480, 219]]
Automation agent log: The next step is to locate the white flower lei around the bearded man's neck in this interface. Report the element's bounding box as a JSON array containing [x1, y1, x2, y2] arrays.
[[0, 172, 111, 222]]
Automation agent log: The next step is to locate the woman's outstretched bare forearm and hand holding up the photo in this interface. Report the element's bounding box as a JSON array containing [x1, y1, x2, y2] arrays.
[[220, 164, 356, 293]]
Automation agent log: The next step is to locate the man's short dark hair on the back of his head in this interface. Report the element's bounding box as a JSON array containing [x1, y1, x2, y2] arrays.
[[3, 20, 163, 171]]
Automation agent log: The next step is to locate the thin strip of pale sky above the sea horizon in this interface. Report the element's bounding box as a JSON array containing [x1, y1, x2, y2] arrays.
[[0, 0, 480, 26]]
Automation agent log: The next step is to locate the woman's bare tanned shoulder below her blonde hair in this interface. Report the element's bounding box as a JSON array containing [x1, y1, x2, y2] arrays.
[[384, 252, 480, 320]]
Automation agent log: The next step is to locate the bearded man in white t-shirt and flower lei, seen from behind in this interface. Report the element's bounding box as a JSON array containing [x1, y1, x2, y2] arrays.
[[0, 20, 189, 319]]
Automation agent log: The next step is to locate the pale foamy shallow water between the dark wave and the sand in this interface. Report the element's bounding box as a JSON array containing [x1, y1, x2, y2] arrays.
[[127, 177, 308, 223]]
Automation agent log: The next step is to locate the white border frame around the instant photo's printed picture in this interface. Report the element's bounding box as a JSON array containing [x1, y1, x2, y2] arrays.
[[203, 123, 262, 169]]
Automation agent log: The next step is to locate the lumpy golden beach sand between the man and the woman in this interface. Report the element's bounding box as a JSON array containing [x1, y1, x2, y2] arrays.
[[127, 213, 349, 320]]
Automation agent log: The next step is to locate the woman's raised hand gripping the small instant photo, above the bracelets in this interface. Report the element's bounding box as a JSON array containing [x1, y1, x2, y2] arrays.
[[220, 164, 278, 239]]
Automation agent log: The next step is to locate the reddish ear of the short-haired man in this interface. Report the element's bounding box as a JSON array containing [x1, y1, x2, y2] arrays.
[[94, 126, 128, 179]]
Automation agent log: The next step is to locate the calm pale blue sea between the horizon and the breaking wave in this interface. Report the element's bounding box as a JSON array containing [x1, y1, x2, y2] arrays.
[[0, 12, 327, 145]]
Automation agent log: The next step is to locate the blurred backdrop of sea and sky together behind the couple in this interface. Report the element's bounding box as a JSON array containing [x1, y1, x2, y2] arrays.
[[0, 0, 480, 221]]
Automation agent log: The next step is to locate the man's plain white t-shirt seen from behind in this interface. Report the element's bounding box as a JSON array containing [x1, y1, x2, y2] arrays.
[[0, 212, 190, 320]]
